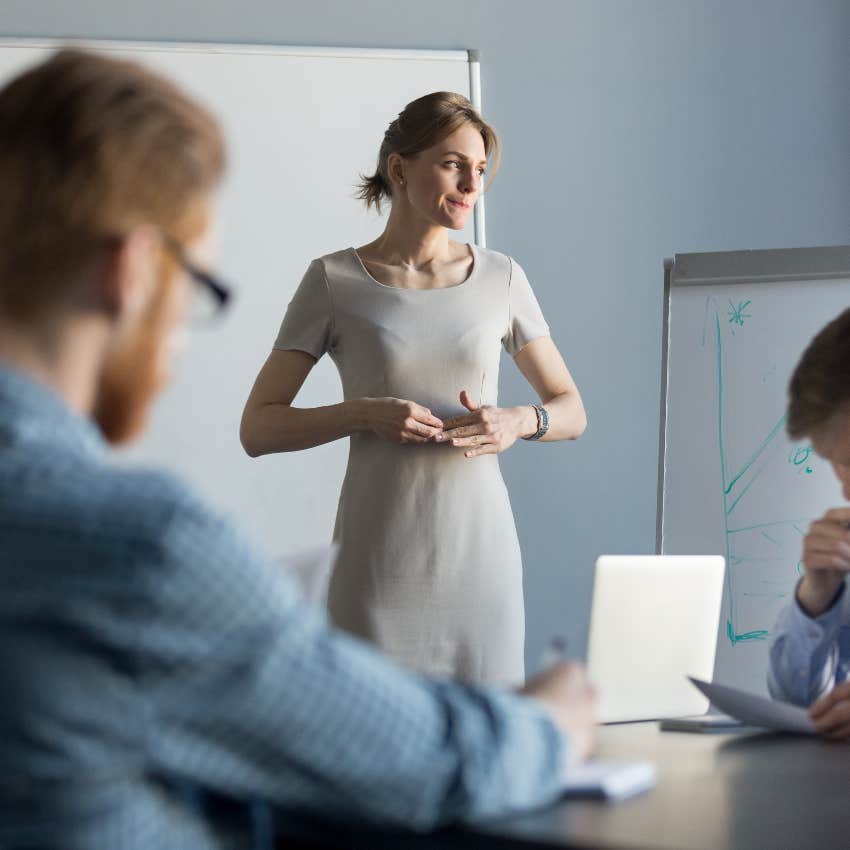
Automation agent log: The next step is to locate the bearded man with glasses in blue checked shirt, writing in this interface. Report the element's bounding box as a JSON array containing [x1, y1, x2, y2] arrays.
[[0, 51, 594, 850]]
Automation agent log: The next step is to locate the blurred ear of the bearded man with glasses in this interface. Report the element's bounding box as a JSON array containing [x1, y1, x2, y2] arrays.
[[101, 226, 160, 321]]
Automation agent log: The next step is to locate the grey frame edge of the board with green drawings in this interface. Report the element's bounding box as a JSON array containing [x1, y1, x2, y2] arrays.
[[655, 245, 850, 555]]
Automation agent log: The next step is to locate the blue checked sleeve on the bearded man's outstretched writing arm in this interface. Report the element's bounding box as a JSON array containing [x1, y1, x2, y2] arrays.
[[140, 490, 569, 828]]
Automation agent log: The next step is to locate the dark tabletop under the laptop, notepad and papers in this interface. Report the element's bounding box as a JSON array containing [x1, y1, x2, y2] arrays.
[[281, 723, 850, 850]]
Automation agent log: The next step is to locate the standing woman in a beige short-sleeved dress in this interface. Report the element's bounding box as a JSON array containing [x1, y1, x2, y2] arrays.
[[241, 92, 585, 684]]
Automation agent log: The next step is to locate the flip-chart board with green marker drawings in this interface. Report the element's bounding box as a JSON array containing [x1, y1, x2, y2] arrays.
[[658, 246, 850, 693]]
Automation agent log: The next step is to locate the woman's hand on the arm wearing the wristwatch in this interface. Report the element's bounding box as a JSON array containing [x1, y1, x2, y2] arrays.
[[443, 390, 537, 457]]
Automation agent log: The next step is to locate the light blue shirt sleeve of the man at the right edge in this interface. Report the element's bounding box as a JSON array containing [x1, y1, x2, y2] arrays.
[[767, 585, 850, 706]]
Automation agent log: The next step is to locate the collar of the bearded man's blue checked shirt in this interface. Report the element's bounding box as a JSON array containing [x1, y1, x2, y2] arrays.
[[0, 362, 106, 455]]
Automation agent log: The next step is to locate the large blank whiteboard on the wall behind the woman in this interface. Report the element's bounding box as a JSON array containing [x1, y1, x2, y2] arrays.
[[0, 40, 483, 555]]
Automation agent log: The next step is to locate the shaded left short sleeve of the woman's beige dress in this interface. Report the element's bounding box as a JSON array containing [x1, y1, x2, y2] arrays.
[[274, 255, 333, 360]]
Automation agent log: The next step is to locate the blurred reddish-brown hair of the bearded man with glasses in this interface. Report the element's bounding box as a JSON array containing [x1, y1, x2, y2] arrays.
[[0, 49, 226, 316]]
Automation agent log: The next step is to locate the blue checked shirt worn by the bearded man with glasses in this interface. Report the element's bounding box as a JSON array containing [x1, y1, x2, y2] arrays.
[[0, 368, 568, 850]]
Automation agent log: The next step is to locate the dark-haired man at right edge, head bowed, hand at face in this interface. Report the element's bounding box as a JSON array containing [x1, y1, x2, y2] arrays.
[[768, 310, 850, 738]]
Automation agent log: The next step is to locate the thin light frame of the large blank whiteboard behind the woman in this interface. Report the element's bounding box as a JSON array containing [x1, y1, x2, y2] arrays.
[[0, 37, 487, 248]]
